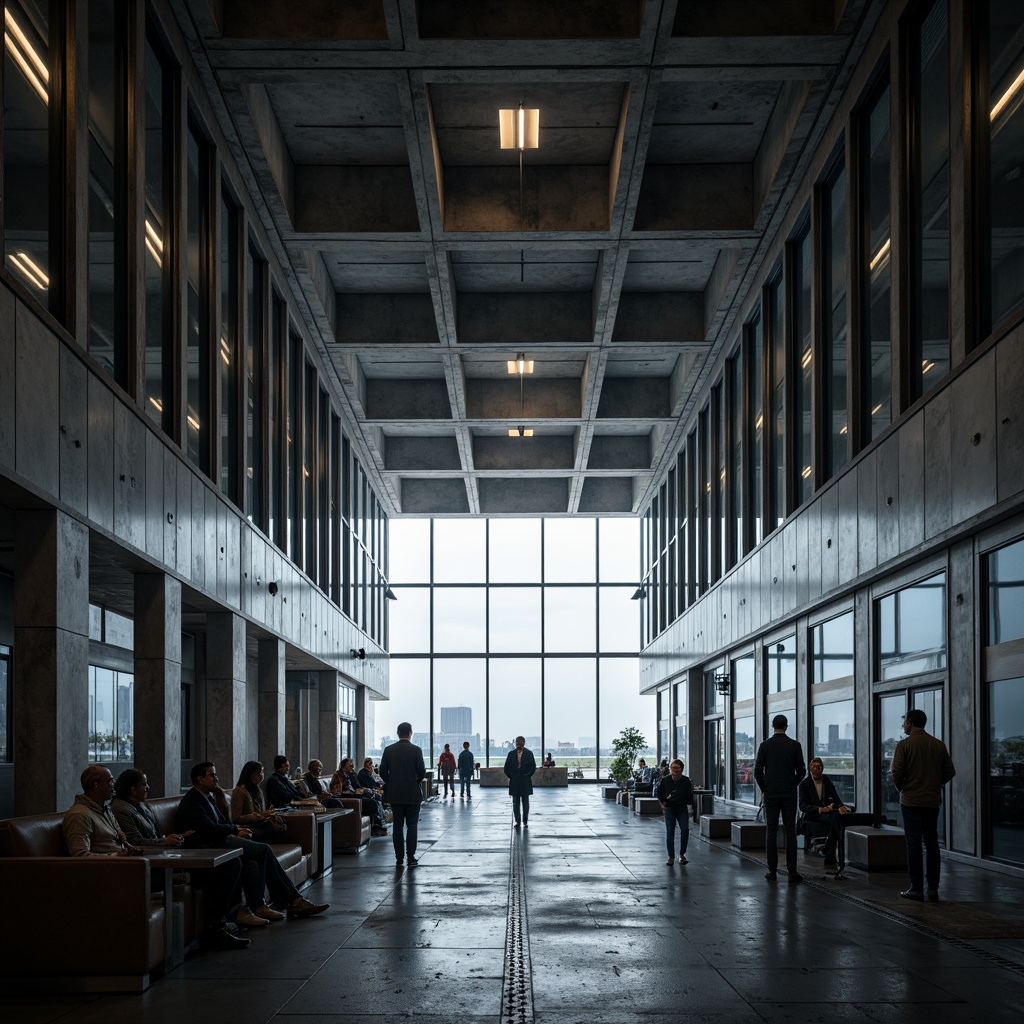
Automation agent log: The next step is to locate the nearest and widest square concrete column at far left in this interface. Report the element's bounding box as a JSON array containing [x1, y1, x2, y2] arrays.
[[14, 509, 89, 815]]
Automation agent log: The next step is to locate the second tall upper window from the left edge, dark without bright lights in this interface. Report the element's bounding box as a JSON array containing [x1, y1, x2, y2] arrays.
[[87, 0, 128, 386]]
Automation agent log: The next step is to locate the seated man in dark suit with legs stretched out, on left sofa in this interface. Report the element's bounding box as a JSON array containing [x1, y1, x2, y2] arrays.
[[178, 761, 329, 924]]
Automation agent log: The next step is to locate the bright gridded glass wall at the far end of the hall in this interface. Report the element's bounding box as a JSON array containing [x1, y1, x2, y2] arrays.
[[385, 518, 657, 779]]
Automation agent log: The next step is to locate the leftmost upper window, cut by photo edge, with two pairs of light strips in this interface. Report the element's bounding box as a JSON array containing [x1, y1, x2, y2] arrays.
[[3, 0, 50, 305]]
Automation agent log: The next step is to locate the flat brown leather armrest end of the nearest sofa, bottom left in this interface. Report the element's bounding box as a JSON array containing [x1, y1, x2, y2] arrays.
[[0, 857, 164, 977]]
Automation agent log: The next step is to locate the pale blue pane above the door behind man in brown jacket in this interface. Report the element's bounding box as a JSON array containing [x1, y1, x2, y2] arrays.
[[879, 572, 946, 679]]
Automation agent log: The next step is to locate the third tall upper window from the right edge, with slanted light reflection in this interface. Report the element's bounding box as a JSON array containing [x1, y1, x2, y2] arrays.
[[860, 83, 892, 442]]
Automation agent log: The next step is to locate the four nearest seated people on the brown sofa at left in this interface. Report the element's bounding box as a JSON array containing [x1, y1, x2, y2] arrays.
[[63, 759, 344, 949]]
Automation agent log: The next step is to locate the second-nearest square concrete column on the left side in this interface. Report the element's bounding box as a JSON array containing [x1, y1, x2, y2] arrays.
[[134, 572, 181, 797]]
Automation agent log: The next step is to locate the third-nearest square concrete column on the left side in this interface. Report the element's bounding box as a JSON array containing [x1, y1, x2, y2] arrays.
[[203, 611, 250, 788]]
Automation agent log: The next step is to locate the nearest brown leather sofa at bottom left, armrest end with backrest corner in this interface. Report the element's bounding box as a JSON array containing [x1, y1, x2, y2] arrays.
[[0, 813, 165, 992]]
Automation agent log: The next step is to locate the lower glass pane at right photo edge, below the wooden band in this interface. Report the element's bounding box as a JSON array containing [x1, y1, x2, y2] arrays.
[[986, 678, 1024, 864]]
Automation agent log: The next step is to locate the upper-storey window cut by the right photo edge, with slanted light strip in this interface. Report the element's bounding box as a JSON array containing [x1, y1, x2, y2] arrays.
[[982, 0, 1024, 328]]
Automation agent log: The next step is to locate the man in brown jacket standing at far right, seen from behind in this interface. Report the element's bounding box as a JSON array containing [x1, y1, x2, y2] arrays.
[[890, 708, 956, 902]]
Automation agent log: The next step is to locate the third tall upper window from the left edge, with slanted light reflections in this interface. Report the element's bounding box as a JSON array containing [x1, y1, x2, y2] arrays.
[[143, 30, 174, 431]]
